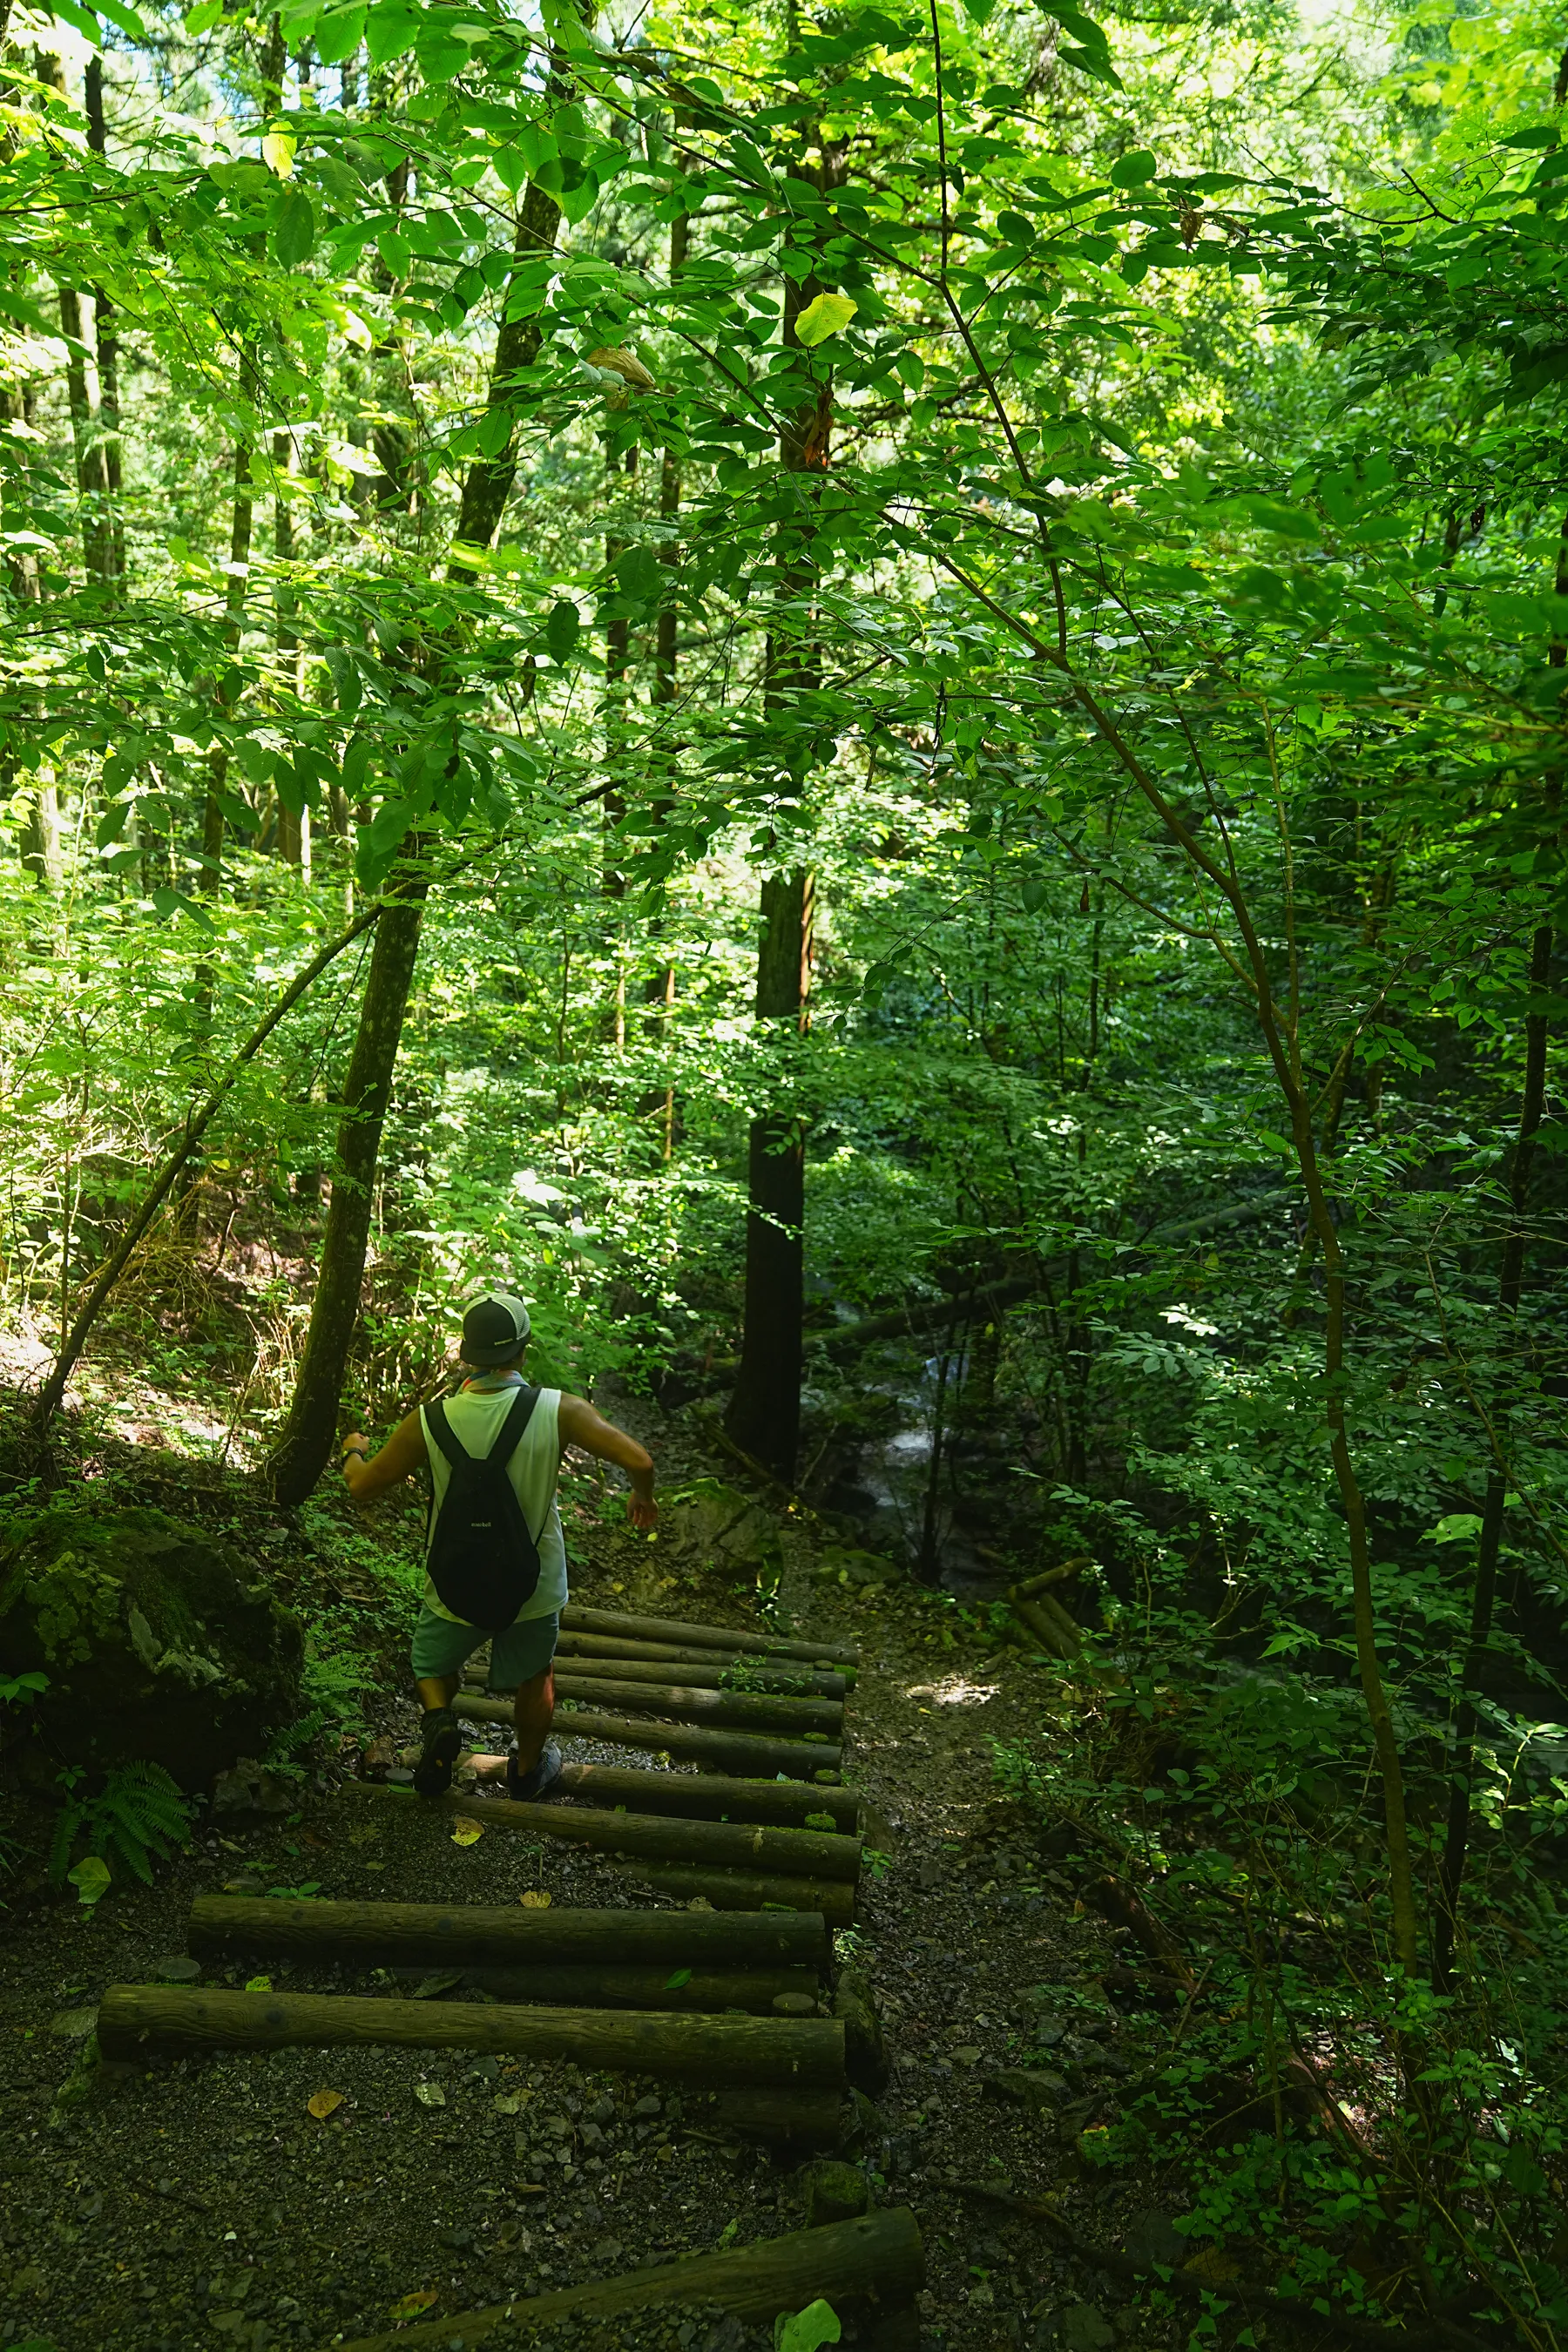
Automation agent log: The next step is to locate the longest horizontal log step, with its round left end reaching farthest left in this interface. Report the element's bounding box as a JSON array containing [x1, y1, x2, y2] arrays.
[[98, 1985, 844, 2089]]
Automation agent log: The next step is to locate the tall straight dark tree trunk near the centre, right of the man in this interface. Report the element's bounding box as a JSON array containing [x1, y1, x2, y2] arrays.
[[724, 133, 839, 1484]]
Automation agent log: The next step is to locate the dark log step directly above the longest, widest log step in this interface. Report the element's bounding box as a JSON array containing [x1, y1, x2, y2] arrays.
[[188, 1896, 828, 1978]]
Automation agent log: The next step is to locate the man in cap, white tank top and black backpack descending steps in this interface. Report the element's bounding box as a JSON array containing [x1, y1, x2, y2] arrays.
[[343, 1291, 659, 1800]]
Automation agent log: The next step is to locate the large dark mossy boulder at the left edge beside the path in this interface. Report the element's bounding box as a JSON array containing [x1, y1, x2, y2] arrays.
[[0, 1503, 303, 1788]]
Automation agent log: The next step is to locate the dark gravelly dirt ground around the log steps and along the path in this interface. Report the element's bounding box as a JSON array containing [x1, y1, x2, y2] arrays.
[[0, 1373, 1182, 2352]]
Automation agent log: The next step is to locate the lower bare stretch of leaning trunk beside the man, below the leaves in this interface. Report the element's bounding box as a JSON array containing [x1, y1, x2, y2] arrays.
[[268, 875, 428, 1505]]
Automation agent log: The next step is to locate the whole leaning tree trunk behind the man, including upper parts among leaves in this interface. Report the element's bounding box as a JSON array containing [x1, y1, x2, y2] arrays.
[[266, 114, 573, 1505]]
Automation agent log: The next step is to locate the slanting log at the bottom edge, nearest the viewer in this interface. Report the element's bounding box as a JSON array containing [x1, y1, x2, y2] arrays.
[[339, 2207, 926, 2352]]
